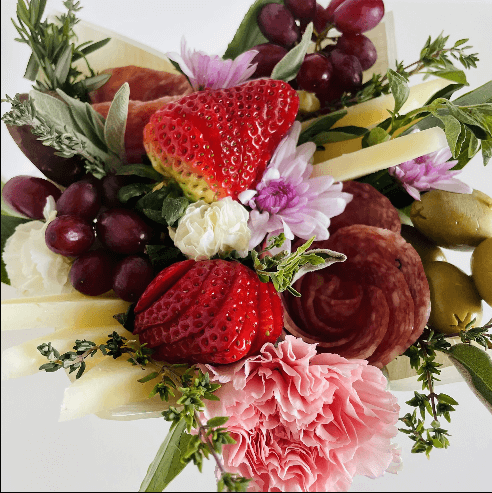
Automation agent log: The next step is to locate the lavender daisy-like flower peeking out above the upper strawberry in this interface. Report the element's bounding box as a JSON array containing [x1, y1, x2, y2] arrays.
[[166, 37, 258, 91]]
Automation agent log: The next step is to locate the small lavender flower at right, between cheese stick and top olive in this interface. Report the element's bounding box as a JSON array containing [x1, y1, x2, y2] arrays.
[[388, 131, 473, 200]]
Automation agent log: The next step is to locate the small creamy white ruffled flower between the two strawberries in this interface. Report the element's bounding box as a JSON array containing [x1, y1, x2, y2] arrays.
[[170, 197, 251, 260]]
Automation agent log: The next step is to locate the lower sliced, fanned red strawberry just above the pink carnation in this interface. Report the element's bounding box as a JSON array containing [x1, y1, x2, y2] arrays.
[[134, 260, 283, 364]]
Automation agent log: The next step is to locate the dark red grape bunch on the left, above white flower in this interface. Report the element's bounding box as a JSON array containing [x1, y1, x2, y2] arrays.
[[2, 175, 154, 301]]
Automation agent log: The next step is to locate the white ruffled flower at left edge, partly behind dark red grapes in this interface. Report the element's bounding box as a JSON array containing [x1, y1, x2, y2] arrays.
[[3, 196, 74, 296]]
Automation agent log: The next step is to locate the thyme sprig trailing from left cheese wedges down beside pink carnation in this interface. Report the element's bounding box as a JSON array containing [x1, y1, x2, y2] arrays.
[[37, 331, 251, 491]]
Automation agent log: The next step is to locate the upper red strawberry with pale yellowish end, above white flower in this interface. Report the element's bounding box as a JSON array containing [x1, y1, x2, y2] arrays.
[[144, 79, 299, 203]]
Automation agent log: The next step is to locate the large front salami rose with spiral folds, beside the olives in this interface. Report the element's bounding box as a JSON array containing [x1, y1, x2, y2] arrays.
[[284, 225, 430, 367]]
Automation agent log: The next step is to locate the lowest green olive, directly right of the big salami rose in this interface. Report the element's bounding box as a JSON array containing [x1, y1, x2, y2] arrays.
[[424, 262, 482, 334]]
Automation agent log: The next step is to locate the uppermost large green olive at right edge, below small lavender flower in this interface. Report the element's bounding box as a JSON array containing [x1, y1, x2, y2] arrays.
[[410, 190, 492, 251]]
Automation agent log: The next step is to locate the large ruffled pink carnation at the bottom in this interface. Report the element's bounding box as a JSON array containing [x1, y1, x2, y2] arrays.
[[205, 336, 399, 491]]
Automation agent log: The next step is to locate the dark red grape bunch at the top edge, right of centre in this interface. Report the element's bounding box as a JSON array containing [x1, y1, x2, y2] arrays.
[[252, 0, 384, 105]]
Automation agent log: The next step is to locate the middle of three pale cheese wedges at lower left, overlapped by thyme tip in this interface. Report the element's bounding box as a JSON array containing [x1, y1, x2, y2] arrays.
[[2, 324, 134, 380]]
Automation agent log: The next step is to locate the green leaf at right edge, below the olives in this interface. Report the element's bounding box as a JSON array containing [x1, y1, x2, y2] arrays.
[[447, 344, 492, 412]]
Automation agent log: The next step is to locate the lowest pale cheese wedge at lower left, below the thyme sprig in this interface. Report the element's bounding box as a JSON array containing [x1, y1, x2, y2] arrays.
[[60, 357, 179, 421]]
